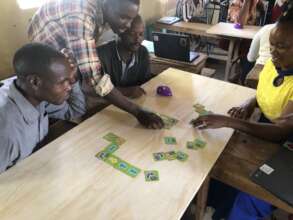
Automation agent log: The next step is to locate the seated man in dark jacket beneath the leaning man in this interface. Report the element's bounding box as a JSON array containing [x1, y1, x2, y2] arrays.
[[97, 15, 153, 98]]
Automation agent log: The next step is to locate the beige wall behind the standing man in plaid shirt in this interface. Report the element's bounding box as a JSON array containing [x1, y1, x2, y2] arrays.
[[0, 0, 176, 79]]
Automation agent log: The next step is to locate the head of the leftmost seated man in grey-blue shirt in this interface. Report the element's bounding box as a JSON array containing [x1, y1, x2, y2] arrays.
[[13, 43, 76, 105]]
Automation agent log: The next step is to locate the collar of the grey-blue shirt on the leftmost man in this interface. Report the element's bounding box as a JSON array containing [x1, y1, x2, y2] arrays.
[[8, 81, 45, 124]]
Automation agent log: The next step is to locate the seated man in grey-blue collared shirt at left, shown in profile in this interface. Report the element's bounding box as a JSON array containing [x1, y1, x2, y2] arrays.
[[0, 43, 85, 172]]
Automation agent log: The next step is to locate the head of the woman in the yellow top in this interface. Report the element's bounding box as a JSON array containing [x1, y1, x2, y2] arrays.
[[270, 7, 293, 70]]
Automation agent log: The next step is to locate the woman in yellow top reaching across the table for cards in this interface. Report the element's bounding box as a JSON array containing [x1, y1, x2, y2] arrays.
[[191, 7, 293, 141]]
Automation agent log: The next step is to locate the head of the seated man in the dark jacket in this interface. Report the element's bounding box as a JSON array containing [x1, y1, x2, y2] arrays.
[[120, 15, 144, 52]]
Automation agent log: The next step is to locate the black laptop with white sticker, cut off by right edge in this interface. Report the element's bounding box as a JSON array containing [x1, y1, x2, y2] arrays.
[[251, 147, 293, 205]]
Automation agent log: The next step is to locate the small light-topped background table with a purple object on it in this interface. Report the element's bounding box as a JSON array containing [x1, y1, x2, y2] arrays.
[[206, 22, 261, 80]]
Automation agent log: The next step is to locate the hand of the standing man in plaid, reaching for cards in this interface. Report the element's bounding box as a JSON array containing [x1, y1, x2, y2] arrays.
[[136, 109, 164, 129]]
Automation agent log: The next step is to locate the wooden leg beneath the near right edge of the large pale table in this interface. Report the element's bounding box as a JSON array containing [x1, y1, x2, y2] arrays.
[[195, 176, 210, 220]]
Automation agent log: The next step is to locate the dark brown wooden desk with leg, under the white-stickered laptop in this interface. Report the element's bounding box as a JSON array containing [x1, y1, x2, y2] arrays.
[[196, 132, 293, 220]]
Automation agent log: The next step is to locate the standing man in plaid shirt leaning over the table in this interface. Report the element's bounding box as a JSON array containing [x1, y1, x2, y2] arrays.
[[28, 0, 163, 128]]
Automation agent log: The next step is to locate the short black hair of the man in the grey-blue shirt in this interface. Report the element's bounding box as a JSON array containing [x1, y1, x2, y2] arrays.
[[13, 43, 65, 77]]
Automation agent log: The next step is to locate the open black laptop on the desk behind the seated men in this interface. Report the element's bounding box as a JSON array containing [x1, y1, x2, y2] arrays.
[[153, 32, 199, 62]]
